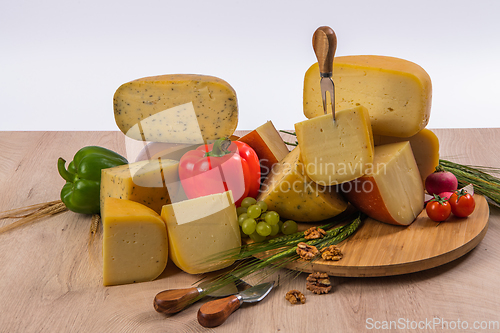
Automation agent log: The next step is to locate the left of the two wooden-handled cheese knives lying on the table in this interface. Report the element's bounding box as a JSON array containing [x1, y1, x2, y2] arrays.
[[153, 279, 252, 314]]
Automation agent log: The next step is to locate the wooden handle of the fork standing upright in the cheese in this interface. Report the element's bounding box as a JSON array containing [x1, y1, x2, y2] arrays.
[[313, 26, 337, 76]]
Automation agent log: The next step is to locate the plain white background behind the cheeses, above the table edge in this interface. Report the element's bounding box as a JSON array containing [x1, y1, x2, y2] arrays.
[[0, 0, 500, 130]]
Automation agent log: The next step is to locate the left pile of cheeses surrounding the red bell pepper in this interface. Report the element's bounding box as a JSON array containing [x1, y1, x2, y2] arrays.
[[101, 74, 294, 285]]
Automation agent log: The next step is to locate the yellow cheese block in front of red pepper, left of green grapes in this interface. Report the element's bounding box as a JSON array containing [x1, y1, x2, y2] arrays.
[[161, 191, 241, 274]]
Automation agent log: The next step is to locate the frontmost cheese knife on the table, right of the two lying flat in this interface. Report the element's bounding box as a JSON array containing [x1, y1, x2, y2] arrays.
[[198, 282, 274, 327]]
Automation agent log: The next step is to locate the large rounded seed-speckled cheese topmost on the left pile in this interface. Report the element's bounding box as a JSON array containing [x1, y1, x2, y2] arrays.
[[113, 74, 238, 143]]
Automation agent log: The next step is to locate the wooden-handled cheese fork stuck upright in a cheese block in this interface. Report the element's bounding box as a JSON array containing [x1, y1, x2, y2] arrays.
[[313, 26, 337, 122]]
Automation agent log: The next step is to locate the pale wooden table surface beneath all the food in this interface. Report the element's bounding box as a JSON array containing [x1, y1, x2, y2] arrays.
[[0, 129, 500, 333]]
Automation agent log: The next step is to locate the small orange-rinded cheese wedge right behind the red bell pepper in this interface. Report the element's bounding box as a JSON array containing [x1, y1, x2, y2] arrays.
[[238, 121, 289, 176]]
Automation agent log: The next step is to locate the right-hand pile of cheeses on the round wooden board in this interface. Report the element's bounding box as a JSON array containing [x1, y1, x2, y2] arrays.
[[259, 56, 439, 225]]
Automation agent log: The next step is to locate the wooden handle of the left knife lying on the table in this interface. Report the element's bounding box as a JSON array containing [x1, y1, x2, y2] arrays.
[[153, 287, 200, 314]]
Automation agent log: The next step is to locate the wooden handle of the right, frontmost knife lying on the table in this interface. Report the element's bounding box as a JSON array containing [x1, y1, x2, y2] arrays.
[[198, 295, 241, 327]]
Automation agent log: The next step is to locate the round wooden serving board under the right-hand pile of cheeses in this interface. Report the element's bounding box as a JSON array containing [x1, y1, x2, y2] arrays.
[[278, 194, 490, 277]]
